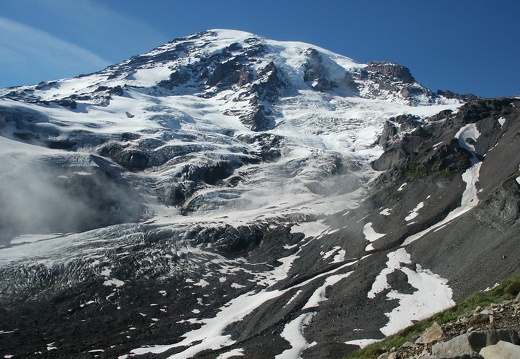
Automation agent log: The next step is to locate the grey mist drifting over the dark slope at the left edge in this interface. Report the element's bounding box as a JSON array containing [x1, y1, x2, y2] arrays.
[[0, 155, 143, 245]]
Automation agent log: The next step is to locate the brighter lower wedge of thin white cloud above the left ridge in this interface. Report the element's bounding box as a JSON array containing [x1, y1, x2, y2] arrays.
[[0, 17, 110, 86]]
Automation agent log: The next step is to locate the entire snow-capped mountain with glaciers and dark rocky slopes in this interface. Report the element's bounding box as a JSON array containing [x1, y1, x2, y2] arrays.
[[0, 30, 520, 358]]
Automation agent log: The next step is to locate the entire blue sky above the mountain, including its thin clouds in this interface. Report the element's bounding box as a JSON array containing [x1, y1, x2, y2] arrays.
[[0, 0, 520, 97]]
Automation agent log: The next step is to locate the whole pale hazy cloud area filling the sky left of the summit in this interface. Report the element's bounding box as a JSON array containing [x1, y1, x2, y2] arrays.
[[0, 0, 168, 87]]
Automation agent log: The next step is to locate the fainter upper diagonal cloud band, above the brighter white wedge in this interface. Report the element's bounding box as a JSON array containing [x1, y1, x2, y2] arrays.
[[2, 0, 169, 62]]
